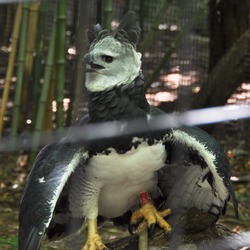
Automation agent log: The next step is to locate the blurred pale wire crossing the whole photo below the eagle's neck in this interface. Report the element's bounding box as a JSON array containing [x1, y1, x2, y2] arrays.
[[0, 105, 250, 153]]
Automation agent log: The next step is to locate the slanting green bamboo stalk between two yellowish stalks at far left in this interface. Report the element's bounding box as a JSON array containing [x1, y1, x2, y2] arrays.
[[11, 2, 28, 150]]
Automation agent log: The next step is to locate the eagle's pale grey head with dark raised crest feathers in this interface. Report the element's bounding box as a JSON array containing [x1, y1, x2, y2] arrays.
[[84, 11, 141, 92]]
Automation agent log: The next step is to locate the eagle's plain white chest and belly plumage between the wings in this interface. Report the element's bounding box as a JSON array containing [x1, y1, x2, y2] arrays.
[[86, 142, 166, 217]]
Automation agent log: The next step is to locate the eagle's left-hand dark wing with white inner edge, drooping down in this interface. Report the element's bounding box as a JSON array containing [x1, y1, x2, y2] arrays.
[[19, 140, 87, 250]]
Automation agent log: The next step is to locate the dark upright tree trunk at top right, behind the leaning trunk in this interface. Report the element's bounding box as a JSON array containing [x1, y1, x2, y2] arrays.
[[209, 0, 249, 71]]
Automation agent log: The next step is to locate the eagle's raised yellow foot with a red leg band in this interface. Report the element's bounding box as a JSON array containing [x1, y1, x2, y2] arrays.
[[129, 192, 171, 234]]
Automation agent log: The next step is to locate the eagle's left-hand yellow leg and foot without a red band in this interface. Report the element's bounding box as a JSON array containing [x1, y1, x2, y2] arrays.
[[82, 218, 107, 250]]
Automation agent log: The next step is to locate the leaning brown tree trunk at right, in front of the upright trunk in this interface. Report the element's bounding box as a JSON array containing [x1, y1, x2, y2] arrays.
[[191, 30, 250, 108]]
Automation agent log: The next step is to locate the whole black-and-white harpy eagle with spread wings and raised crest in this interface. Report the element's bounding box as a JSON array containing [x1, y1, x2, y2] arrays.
[[19, 11, 237, 250]]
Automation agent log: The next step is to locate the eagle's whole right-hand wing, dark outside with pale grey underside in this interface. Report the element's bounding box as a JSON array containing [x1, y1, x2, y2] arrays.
[[159, 127, 238, 217]]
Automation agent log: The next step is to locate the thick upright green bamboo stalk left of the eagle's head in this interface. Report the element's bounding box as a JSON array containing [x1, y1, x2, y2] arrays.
[[56, 0, 67, 129]]
